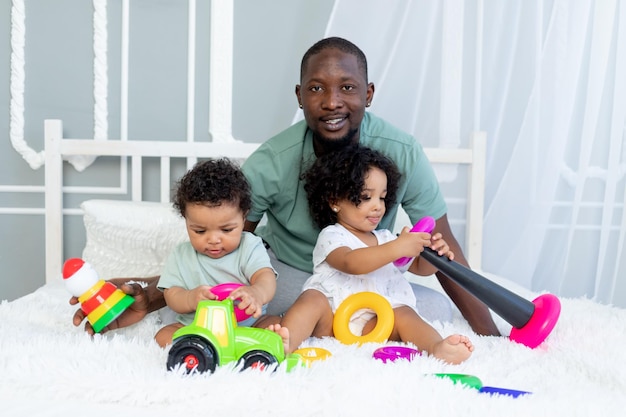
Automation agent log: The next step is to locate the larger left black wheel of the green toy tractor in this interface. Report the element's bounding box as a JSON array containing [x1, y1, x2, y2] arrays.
[[167, 336, 219, 374]]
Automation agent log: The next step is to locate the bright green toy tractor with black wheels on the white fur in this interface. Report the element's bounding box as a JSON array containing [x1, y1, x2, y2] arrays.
[[167, 298, 305, 373]]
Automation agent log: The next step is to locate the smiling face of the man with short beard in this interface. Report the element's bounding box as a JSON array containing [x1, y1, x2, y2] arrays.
[[296, 49, 374, 154]]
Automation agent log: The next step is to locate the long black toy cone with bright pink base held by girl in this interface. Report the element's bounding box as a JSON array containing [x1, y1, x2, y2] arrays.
[[404, 214, 561, 349]]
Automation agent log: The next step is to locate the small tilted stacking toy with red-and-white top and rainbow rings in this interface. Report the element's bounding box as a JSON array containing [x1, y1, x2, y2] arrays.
[[63, 258, 135, 333]]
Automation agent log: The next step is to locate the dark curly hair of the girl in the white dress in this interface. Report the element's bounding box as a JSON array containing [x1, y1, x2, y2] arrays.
[[302, 144, 401, 229]]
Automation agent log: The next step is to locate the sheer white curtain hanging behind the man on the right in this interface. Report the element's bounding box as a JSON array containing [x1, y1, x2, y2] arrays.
[[326, 0, 626, 307]]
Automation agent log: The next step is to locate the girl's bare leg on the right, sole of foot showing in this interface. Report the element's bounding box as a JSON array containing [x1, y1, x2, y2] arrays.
[[390, 306, 474, 364]]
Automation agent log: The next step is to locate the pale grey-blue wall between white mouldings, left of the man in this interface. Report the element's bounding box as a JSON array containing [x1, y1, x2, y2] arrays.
[[0, 0, 333, 300]]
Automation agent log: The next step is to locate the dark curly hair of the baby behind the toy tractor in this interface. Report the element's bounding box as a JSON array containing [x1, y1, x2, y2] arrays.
[[173, 158, 252, 217]]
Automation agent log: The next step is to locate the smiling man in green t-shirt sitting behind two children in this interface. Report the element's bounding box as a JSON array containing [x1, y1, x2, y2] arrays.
[[242, 37, 499, 335]]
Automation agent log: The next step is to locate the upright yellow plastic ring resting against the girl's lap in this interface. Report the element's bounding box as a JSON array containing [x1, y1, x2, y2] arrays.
[[333, 292, 394, 345]]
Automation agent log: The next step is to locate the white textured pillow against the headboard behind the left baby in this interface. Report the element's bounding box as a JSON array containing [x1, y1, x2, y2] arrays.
[[81, 200, 189, 279]]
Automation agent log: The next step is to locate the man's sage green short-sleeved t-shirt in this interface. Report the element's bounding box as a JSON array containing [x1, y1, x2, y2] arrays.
[[242, 113, 447, 272]]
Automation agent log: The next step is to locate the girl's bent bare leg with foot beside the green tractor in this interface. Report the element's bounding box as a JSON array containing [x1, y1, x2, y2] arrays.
[[267, 290, 333, 353]]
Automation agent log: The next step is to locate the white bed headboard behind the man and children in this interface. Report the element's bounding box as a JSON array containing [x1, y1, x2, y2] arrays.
[[44, 120, 486, 283]]
